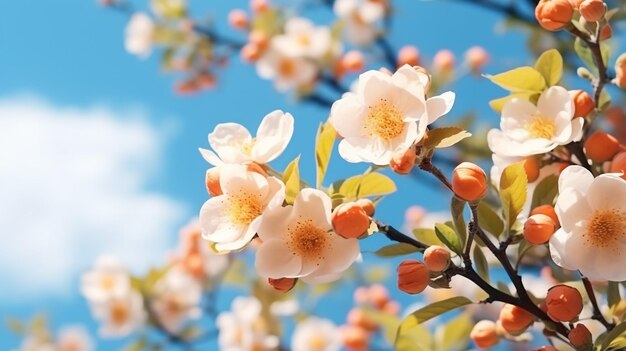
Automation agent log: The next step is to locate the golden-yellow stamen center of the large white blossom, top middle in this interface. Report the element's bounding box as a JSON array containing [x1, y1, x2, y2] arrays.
[[364, 99, 404, 140]]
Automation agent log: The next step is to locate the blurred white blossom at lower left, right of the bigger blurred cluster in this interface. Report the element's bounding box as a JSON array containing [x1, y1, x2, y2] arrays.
[[152, 267, 202, 333]]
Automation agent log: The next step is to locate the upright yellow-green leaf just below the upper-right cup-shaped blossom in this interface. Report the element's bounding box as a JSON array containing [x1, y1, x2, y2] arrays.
[[500, 162, 528, 229]]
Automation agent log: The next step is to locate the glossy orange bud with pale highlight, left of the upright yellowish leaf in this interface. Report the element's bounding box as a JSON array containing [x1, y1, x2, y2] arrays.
[[452, 162, 487, 202]]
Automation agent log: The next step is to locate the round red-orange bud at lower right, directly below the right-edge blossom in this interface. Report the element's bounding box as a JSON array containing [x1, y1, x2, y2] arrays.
[[546, 284, 583, 322]]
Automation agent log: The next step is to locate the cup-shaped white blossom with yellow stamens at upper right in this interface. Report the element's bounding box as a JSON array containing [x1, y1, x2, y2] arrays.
[[487, 86, 584, 157]]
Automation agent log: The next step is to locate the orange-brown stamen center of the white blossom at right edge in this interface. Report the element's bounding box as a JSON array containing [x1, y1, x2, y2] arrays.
[[583, 209, 626, 248]]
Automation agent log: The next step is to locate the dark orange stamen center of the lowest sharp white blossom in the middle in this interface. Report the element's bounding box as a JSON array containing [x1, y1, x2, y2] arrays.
[[287, 219, 330, 265]]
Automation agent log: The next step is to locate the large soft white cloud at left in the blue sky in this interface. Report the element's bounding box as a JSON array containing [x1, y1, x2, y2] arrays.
[[0, 98, 186, 298]]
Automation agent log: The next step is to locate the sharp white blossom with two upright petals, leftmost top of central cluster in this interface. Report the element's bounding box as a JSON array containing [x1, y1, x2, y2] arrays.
[[200, 110, 294, 166]]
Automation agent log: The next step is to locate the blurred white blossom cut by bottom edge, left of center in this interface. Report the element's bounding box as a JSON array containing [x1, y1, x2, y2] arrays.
[[216, 296, 279, 351]]
